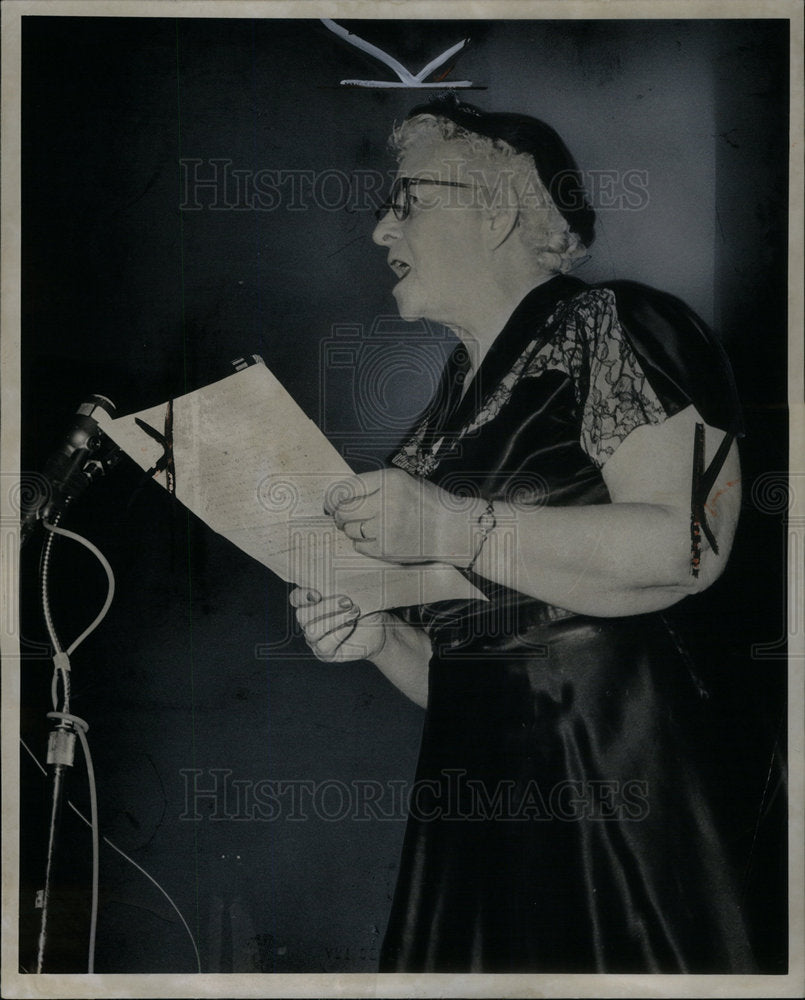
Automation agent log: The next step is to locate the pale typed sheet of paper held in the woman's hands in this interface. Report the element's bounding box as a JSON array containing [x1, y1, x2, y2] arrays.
[[94, 364, 483, 614]]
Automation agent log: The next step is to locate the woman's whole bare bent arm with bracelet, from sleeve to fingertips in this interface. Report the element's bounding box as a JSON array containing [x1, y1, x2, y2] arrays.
[[334, 407, 741, 616]]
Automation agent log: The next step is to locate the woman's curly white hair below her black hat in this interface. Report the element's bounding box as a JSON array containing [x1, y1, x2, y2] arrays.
[[389, 114, 587, 274]]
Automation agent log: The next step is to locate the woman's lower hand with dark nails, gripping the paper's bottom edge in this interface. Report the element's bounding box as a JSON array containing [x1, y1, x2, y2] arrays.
[[289, 587, 390, 663]]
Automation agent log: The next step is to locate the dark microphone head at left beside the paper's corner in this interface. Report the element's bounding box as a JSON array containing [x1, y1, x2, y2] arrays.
[[20, 396, 120, 546]]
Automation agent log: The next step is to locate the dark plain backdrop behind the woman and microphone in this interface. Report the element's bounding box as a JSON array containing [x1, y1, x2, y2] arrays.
[[21, 17, 788, 972]]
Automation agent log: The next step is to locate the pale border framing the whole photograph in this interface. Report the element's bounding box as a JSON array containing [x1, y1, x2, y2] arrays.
[[0, 0, 805, 998]]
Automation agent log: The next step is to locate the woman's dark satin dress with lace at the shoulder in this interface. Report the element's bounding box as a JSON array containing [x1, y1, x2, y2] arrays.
[[381, 276, 753, 973]]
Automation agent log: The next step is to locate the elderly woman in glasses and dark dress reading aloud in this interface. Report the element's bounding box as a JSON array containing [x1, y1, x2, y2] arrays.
[[291, 97, 753, 972]]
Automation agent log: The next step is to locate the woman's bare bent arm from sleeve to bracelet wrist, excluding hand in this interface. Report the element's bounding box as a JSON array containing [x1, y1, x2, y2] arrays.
[[439, 408, 741, 616]]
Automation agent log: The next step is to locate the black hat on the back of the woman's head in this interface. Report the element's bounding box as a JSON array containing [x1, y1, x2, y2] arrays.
[[407, 93, 595, 246]]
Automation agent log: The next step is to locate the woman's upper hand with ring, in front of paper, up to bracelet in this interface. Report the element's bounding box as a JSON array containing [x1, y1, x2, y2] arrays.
[[324, 469, 468, 565]]
